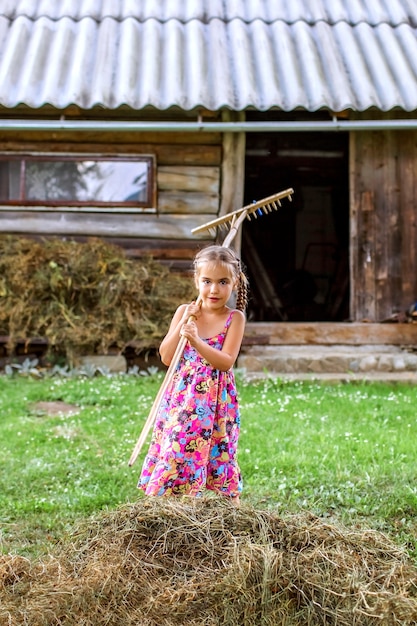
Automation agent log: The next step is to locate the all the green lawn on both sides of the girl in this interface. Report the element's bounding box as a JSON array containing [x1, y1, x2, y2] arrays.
[[0, 374, 417, 556]]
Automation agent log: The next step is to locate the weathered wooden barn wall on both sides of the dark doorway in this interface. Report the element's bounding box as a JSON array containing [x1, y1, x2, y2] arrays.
[[0, 106, 417, 322]]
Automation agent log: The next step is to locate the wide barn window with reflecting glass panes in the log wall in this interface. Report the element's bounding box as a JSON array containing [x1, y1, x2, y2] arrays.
[[0, 154, 155, 210]]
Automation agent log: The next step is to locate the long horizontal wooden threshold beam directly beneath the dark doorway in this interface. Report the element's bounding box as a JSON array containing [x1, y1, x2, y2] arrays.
[[243, 322, 417, 346]]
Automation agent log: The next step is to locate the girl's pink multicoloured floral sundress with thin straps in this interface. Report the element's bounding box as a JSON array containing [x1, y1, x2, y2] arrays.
[[138, 311, 242, 497]]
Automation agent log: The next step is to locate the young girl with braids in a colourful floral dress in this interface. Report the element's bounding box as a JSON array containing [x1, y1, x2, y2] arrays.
[[138, 246, 247, 503]]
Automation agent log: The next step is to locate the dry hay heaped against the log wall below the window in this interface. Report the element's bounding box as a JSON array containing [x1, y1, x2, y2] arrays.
[[0, 235, 195, 362]]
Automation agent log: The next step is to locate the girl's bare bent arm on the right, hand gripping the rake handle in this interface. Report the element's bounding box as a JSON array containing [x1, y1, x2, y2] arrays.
[[182, 310, 246, 372]]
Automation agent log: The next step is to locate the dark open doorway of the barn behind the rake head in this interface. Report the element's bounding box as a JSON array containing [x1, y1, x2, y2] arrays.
[[242, 114, 349, 321]]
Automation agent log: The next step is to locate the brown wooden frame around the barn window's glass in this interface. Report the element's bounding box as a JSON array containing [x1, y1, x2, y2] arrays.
[[0, 151, 157, 213]]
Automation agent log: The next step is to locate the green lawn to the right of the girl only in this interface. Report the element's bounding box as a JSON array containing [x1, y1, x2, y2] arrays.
[[240, 381, 417, 550]]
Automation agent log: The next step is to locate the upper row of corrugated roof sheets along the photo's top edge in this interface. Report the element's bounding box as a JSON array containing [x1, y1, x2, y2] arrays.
[[0, 0, 417, 26]]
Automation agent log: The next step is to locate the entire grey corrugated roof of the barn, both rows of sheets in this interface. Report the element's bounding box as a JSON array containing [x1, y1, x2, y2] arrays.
[[0, 0, 417, 111]]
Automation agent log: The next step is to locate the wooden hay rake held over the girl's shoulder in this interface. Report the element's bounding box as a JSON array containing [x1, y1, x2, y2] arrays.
[[129, 188, 294, 466]]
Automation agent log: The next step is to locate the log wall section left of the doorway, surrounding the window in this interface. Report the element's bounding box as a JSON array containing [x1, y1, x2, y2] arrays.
[[0, 113, 244, 269]]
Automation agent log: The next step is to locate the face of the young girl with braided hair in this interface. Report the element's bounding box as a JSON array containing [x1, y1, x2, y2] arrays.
[[195, 263, 236, 309]]
